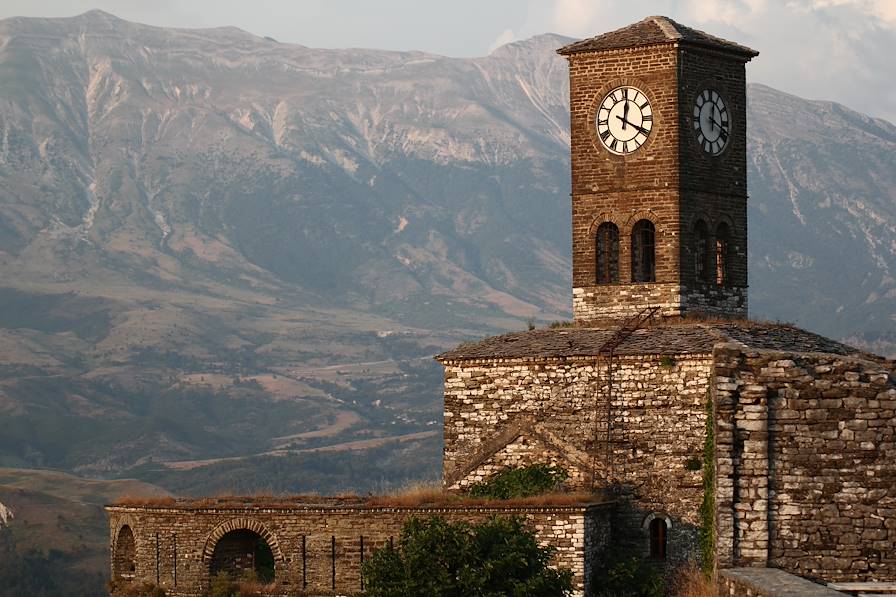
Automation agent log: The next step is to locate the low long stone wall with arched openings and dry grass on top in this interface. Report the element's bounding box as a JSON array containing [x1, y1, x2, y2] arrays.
[[107, 503, 609, 597]]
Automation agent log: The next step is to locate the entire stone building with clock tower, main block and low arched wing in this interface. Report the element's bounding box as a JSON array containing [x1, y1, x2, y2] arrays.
[[108, 17, 896, 595]]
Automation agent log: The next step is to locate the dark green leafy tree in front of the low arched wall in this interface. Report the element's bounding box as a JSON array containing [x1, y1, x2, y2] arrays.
[[363, 517, 572, 597]]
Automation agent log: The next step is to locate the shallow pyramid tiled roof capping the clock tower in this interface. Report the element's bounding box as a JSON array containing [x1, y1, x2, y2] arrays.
[[557, 16, 759, 60]]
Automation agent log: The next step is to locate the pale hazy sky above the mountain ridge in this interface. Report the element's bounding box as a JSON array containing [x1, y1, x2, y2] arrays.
[[0, 0, 896, 122]]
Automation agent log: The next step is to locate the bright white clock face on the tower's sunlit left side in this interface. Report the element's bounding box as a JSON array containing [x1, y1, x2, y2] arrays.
[[596, 87, 653, 155]]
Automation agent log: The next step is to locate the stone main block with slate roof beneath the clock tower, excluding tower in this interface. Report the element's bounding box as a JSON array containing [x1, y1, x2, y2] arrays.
[[440, 323, 896, 581]]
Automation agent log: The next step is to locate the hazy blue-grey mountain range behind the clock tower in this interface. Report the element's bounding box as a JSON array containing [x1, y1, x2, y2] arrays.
[[0, 11, 896, 493]]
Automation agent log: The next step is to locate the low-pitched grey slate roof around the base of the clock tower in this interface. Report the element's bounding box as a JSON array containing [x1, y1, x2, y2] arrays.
[[436, 322, 877, 362]]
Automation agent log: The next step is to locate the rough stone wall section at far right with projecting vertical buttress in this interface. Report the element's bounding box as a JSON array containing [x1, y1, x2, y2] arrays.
[[713, 344, 896, 581]]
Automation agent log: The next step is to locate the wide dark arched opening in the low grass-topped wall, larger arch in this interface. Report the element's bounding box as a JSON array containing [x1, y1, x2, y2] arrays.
[[209, 529, 274, 583]]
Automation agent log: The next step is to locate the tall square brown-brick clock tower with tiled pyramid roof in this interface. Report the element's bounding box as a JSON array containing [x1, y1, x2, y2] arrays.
[[558, 17, 758, 323]]
